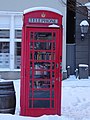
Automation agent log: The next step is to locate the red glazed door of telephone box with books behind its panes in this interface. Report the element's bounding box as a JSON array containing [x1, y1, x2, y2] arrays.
[[25, 27, 62, 116]]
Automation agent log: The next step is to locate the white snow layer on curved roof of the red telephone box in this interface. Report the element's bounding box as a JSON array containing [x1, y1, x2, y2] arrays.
[[24, 7, 62, 15]]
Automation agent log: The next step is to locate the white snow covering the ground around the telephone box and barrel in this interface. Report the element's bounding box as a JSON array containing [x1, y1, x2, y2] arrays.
[[0, 76, 90, 120]]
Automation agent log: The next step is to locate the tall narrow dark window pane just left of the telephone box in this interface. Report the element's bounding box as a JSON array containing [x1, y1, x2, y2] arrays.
[[15, 42, 21, 69]]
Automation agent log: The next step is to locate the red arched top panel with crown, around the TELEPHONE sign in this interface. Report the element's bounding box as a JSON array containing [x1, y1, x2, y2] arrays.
[[23, 10, 62, 27]]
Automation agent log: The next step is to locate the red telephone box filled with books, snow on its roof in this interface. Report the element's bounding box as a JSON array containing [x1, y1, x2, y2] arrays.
[[20, 7, 62, 116]]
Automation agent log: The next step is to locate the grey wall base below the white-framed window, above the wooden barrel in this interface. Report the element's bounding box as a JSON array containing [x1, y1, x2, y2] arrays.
[[0, 71, 20, 80]]
